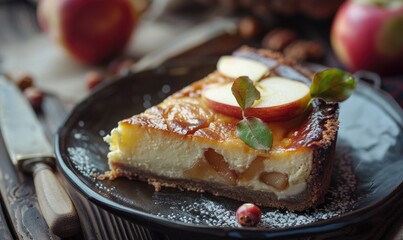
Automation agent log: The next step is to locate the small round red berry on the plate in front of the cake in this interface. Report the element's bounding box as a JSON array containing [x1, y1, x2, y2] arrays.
[[236, 203, 262, 227]]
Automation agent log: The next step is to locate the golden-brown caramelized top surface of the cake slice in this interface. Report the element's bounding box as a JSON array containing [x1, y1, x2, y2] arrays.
[[124, 72, 336, 150]]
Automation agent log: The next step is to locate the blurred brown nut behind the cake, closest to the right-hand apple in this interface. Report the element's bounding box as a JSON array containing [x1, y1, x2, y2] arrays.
[[284, 41, 324, 61]]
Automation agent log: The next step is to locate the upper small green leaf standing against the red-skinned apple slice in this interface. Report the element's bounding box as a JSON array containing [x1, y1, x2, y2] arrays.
[[231, 76, 260, 111]]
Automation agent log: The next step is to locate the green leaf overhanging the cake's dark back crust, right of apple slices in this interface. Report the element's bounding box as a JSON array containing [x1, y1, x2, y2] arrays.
[[310, 68, 357, 102]]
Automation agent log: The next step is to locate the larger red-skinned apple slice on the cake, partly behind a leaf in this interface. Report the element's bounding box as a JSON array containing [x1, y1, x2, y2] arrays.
[[203, 77, 311, 122]]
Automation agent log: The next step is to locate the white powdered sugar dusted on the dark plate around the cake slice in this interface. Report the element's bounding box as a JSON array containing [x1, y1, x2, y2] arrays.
[[68, 132, 365, 228]]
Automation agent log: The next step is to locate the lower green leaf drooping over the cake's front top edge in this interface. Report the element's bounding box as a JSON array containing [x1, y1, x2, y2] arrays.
[[236, 117, 273, 150]]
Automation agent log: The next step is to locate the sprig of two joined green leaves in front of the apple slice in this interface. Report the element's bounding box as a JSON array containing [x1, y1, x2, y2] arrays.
[[231, 76, 273, 150]]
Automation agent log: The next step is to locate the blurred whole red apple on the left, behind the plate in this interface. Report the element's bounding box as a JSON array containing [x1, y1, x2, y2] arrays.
[[37, 0, 147, 64]]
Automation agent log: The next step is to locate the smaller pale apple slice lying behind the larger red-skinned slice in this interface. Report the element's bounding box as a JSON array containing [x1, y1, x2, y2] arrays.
[[217, 56, 269, 81]]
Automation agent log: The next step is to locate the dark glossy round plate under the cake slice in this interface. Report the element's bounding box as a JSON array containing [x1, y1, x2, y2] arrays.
[[56, 60, 403, 239]]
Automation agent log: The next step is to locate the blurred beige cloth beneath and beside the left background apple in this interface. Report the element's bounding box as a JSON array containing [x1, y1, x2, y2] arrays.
[[0, 21, 185, 109]]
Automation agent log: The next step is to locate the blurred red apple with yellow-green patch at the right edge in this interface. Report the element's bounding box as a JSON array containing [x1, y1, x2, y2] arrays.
[[331, 0, 403, 74]]
